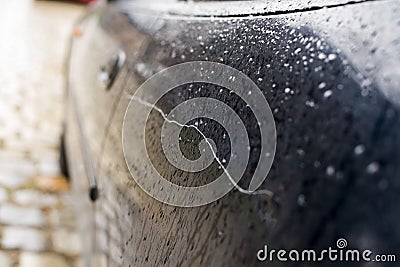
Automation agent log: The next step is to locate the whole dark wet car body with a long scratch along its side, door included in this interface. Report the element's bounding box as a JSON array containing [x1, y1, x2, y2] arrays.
[[66, 0, 400, 266]]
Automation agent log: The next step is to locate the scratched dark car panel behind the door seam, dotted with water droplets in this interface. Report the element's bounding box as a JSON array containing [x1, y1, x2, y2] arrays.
[[96, 1, 400, 266]]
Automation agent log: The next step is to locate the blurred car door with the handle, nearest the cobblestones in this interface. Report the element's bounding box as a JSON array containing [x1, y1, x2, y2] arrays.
[[65, 7, 146, 266]]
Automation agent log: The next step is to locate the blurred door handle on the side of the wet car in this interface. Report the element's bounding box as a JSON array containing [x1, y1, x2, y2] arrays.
[[98, 50, 126, 90]]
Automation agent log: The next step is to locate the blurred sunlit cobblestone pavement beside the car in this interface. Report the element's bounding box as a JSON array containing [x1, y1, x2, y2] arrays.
[[0, 0, 83, 267]]
